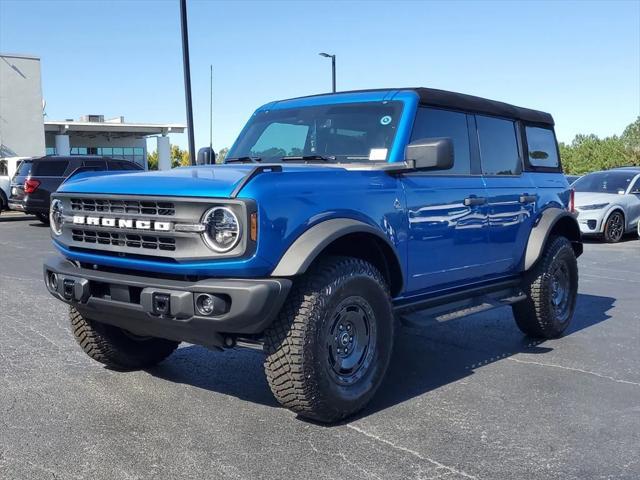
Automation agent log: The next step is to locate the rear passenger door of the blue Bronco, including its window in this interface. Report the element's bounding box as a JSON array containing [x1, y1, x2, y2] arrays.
[[475, 115, 537, 275]]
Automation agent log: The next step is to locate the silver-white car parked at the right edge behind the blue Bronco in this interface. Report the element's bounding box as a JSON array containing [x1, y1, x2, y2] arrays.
[[571, 167, 640, 243]]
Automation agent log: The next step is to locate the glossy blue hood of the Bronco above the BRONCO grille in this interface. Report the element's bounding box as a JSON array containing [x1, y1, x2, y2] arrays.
[[58, 164, 336, 198]]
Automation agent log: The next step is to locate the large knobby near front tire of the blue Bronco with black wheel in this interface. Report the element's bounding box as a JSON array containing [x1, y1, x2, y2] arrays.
[[264, 257, 394, 422]]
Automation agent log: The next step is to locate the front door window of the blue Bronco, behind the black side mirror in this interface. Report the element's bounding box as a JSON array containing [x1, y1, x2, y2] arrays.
[[411, 107, 471, 175]]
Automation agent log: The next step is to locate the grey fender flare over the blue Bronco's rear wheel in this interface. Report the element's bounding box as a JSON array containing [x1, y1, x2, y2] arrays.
[[524, 207, 582, 270]]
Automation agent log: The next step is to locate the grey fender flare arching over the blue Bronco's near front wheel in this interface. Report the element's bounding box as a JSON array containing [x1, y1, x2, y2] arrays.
[[271, 218, 403, 277]]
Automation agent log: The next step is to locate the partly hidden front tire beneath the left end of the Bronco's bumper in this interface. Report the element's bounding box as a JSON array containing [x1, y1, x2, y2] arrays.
[[69, 307, 179, 370]]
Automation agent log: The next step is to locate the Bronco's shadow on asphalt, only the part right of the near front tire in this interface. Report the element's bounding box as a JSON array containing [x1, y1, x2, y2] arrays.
[[352, 294, 615, 420]]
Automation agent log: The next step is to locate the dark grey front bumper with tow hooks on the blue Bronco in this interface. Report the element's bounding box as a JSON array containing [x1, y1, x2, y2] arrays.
[[44, 257, 291, 347]]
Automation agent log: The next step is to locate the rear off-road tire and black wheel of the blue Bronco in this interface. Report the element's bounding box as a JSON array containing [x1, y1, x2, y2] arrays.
[[513, 237, 578, 338]]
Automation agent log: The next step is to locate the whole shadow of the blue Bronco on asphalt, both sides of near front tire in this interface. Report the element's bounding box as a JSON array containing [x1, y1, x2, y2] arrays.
[[148, 294, 615, 423]]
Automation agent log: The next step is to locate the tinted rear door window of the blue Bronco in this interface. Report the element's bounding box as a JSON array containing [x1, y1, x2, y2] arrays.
[[476, 115, 521, 175]]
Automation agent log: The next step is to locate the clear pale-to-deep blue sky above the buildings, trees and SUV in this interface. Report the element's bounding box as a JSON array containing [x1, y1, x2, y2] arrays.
[[0, 0, 640, 150]]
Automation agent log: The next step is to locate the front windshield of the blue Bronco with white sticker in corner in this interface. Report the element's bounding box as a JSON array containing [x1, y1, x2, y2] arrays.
[[227, 102, 402, 162]]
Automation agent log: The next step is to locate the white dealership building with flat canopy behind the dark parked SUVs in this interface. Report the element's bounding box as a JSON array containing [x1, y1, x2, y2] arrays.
[[0, 54, 185, 169]]
